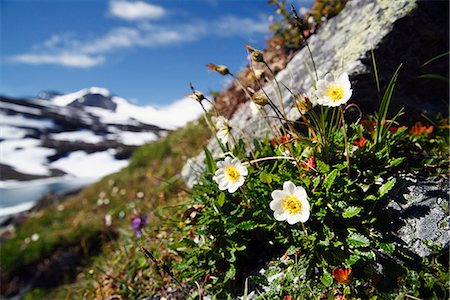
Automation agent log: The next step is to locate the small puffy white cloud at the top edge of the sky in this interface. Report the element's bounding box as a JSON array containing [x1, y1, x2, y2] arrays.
[[109, 0, 166, 21]]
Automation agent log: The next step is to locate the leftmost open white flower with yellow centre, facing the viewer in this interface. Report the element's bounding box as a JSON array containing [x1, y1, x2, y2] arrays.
[[213, 156, 248, 193]]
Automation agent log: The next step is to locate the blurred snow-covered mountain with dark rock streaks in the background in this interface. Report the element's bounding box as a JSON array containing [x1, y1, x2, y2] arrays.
[[0, 87, 202, 185]]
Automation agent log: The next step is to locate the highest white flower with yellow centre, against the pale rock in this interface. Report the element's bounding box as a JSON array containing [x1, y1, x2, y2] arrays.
[[316, 73, 352, 106]]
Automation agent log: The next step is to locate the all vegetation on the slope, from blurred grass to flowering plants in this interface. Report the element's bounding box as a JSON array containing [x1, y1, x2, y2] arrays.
[[1, 1, 449, 300]]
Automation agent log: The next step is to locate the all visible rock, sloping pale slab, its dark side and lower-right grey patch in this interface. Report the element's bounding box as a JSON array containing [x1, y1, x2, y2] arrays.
[[181, 0, 450, 256]]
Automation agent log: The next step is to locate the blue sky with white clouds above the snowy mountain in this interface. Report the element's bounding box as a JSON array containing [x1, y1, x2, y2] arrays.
[[0, 0, 311, 105]]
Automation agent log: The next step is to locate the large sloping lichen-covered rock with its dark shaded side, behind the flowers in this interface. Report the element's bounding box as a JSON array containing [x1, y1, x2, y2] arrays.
[[181, 0, 448, 186]]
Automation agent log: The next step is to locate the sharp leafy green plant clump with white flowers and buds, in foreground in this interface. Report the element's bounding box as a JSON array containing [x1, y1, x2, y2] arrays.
[[153, 11, 448, 299]]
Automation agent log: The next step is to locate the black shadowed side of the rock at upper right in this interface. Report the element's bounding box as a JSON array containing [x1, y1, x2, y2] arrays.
[[352, 1, 449, 121]]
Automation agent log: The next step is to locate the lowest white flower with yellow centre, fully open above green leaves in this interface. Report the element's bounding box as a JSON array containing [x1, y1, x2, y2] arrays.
[[269, 181, 309, 224]]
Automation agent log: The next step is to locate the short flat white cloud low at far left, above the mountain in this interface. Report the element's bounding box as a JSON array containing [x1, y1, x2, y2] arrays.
[[10, 53, 105, 68]]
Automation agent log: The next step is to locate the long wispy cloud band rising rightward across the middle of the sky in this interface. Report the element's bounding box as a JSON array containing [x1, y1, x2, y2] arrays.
[[10, 16, 268, 68]]
